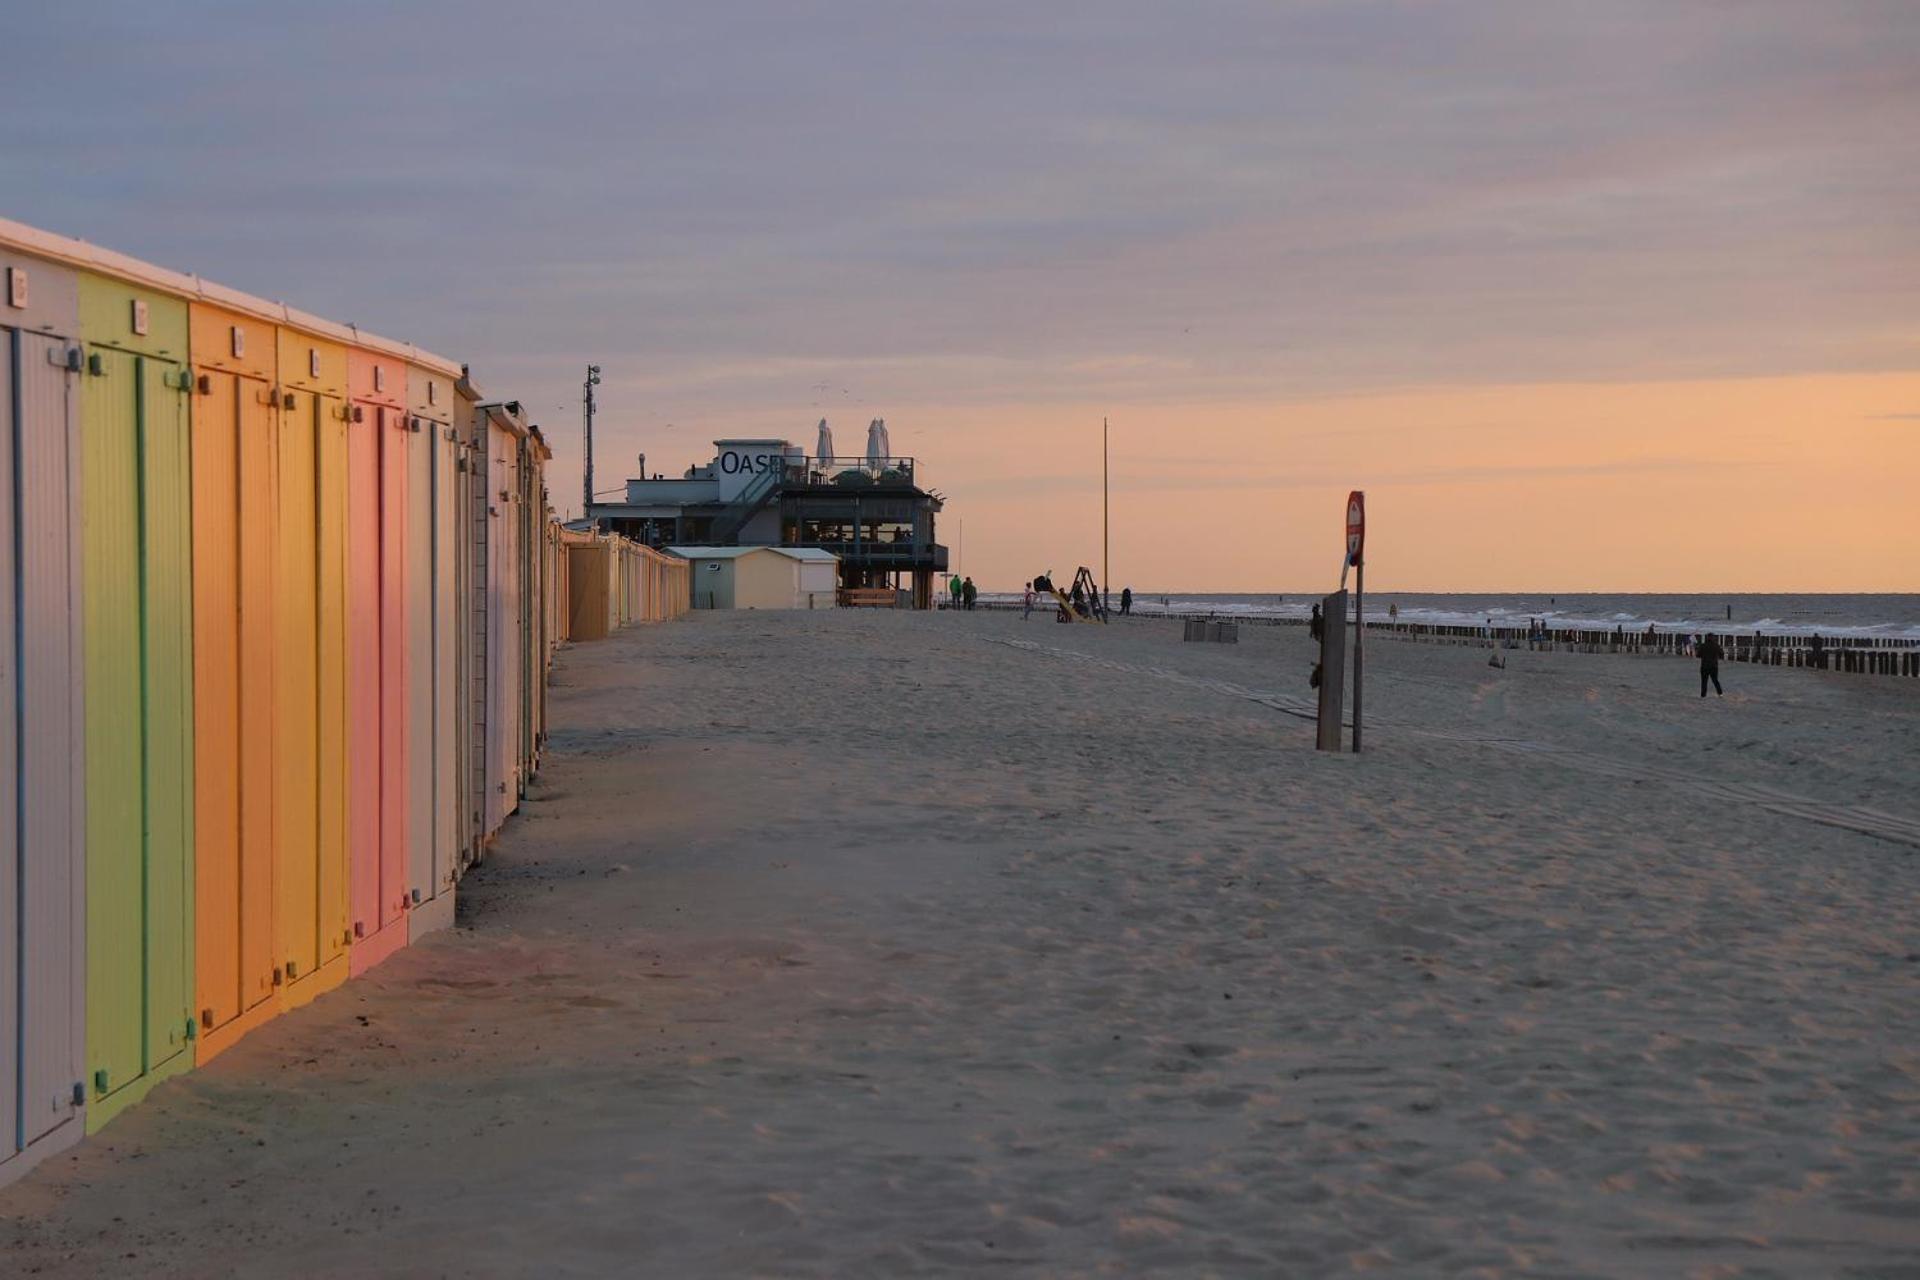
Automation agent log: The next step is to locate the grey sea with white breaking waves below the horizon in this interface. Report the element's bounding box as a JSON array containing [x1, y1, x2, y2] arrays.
[[981, 591, 1920, 643]]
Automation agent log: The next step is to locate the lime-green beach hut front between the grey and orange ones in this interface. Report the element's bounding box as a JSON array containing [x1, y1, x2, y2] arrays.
[[81, 280, 194, 1130]]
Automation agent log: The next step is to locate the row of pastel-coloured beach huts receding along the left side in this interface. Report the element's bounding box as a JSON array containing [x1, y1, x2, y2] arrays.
[[0, 221, 687, 1182]]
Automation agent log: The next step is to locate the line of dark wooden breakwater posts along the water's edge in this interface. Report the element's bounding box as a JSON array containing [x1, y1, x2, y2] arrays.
[[977, 601, 1920, 679]]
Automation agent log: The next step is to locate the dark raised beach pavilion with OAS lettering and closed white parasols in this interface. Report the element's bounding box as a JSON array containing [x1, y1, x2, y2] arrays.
[[588, 433, 947, 608]]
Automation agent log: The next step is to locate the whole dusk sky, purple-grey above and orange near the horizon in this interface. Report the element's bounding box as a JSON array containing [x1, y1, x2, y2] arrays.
[[0, 0, 1920, 591]]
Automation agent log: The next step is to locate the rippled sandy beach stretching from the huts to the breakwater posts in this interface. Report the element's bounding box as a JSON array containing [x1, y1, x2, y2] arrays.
[[0, 610, 1920, 1278]]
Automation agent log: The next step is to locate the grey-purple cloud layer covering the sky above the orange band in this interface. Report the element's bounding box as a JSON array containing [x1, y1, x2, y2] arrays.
[[0, 0, 1920, 514]]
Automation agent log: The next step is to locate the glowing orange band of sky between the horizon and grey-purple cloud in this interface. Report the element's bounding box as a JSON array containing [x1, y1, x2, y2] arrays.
[[927, 374, 1920, 591]]
